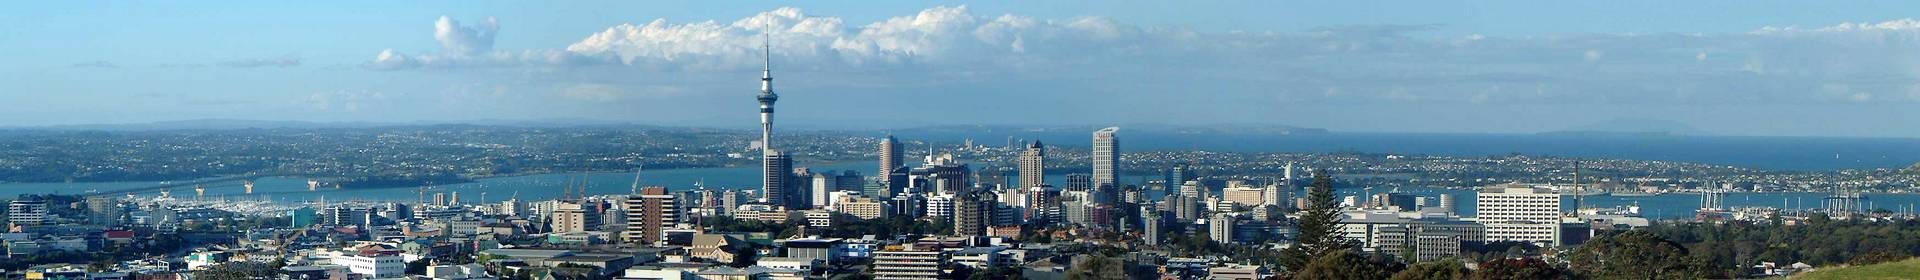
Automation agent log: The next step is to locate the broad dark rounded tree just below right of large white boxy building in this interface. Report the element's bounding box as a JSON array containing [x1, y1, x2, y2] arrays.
[[1567, 230, 1701, 278]]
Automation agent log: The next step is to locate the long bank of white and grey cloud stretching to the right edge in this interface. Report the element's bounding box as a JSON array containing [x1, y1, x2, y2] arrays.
[[367, 6, 1920, 105]]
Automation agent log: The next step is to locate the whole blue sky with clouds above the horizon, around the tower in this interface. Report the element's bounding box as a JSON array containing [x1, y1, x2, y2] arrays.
[[0, 0, 1920, 138]]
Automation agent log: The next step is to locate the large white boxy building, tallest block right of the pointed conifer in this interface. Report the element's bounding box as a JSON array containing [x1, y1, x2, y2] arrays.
[[1475, 184, 1561, 245]]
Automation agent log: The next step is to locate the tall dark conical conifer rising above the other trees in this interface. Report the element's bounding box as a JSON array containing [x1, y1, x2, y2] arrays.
[[1283, 171, 1356, 268]]
